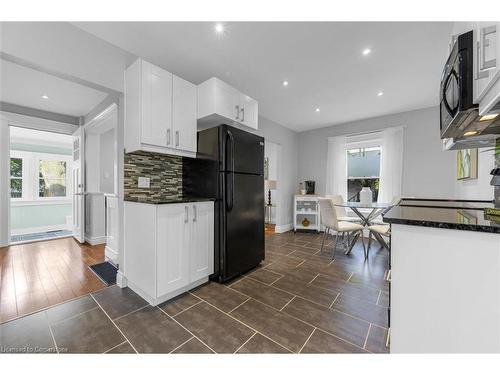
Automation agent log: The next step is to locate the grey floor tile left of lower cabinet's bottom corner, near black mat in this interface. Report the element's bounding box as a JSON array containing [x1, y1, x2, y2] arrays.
[[92, 285, 148, 319]]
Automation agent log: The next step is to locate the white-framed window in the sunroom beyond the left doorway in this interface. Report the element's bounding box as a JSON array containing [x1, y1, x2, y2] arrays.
[[10, 150, 71, 202]]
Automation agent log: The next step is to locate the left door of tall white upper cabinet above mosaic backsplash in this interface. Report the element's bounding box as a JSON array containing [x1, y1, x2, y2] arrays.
[[141, 61, 172, 146]]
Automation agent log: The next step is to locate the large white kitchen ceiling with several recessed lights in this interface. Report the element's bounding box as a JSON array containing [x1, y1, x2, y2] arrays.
[[74, 22, 452, 131]]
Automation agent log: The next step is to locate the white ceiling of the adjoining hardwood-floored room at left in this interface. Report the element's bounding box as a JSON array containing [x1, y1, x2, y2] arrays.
[[0, 59, 107, 116]]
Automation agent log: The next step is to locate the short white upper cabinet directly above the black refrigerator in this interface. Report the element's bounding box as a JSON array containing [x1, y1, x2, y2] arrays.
[[198, 77, 259, 129]]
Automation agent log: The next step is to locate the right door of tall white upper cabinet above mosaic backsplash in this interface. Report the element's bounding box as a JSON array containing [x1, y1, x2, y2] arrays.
[[172, 76, 197, 152]]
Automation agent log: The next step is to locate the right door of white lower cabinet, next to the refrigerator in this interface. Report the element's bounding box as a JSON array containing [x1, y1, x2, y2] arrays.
[[190, 202, 214, 282]]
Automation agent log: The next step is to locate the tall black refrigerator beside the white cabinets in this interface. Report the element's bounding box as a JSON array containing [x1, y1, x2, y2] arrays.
[[183, 125, 265, 282]]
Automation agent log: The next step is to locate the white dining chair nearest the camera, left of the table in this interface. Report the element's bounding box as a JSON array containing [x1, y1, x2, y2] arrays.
[[319, 198, 366, 259]]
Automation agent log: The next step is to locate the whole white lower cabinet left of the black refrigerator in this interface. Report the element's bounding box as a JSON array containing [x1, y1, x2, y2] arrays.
[[124, 202, 214, 305]]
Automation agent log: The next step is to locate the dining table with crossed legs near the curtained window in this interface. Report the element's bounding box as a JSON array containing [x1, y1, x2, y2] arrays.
[[333, 201, 393, 254]]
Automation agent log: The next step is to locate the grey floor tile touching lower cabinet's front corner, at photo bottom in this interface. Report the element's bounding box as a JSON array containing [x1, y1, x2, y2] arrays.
[[115, 306, 192, 353]]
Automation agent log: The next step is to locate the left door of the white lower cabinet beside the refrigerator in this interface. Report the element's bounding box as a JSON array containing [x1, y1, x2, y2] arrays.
[[156, 204, 191, 297]]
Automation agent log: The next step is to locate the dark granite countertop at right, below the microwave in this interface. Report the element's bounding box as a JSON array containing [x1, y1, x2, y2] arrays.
[[383, 201, 500, 233]]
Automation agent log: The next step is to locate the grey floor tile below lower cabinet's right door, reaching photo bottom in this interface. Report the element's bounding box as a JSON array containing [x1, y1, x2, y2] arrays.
[[175, 302, 254, 353]]
